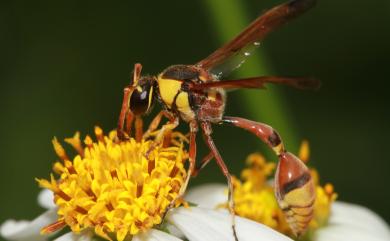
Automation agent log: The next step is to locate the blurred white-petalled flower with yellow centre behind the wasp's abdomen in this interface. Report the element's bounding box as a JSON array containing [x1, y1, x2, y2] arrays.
[[186, 142, 390, 241]]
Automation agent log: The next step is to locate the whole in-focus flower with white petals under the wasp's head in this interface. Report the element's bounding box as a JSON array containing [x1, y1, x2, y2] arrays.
[[0, 127, 298, 241]]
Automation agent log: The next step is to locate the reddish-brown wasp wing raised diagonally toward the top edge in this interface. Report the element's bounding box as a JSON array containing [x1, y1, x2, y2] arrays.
[[196, 0, 316, 77]]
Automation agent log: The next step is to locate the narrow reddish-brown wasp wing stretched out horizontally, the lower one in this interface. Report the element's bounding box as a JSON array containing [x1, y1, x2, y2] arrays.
[[190, 76, 321, 91]]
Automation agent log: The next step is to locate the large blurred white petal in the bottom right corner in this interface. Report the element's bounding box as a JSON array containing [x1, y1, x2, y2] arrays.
[[314, 202, 390, 241]]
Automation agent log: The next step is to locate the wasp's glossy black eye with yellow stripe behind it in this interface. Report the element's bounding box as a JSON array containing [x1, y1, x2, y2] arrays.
[[129, 77, 155, 115]]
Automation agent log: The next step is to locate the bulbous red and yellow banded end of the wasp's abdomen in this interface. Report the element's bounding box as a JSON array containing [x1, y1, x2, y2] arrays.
[[275, 152, 315, 236]]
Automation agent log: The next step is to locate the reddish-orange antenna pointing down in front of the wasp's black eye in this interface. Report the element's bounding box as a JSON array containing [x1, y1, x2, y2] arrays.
[[116, 86, 133, 140]]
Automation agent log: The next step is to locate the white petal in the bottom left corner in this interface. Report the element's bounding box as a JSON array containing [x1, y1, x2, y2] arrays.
[[0, 209, 57, 240]]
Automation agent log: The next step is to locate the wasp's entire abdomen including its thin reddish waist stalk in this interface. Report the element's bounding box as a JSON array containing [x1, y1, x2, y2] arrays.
[[222, 117, 315, 236]]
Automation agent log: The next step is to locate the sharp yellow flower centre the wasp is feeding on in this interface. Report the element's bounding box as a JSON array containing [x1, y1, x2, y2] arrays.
[[37, 127, 187, 241]]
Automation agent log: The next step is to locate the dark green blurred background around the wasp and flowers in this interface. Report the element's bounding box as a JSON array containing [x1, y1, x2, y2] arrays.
[[0, 0, 390, 235]]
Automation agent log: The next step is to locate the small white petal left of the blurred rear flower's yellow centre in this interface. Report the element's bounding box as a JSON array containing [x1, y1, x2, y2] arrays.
[[185, 183, 227, 208]]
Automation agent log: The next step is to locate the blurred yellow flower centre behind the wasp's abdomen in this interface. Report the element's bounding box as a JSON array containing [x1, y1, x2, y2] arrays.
[[224, 141, 337, 237]]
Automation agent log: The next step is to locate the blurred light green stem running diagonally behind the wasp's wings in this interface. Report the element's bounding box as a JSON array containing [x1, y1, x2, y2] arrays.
[[203, 0, 299, 151]]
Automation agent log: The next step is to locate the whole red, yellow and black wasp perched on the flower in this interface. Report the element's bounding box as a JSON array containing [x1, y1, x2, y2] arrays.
[[117, 0, 319, 239]]
